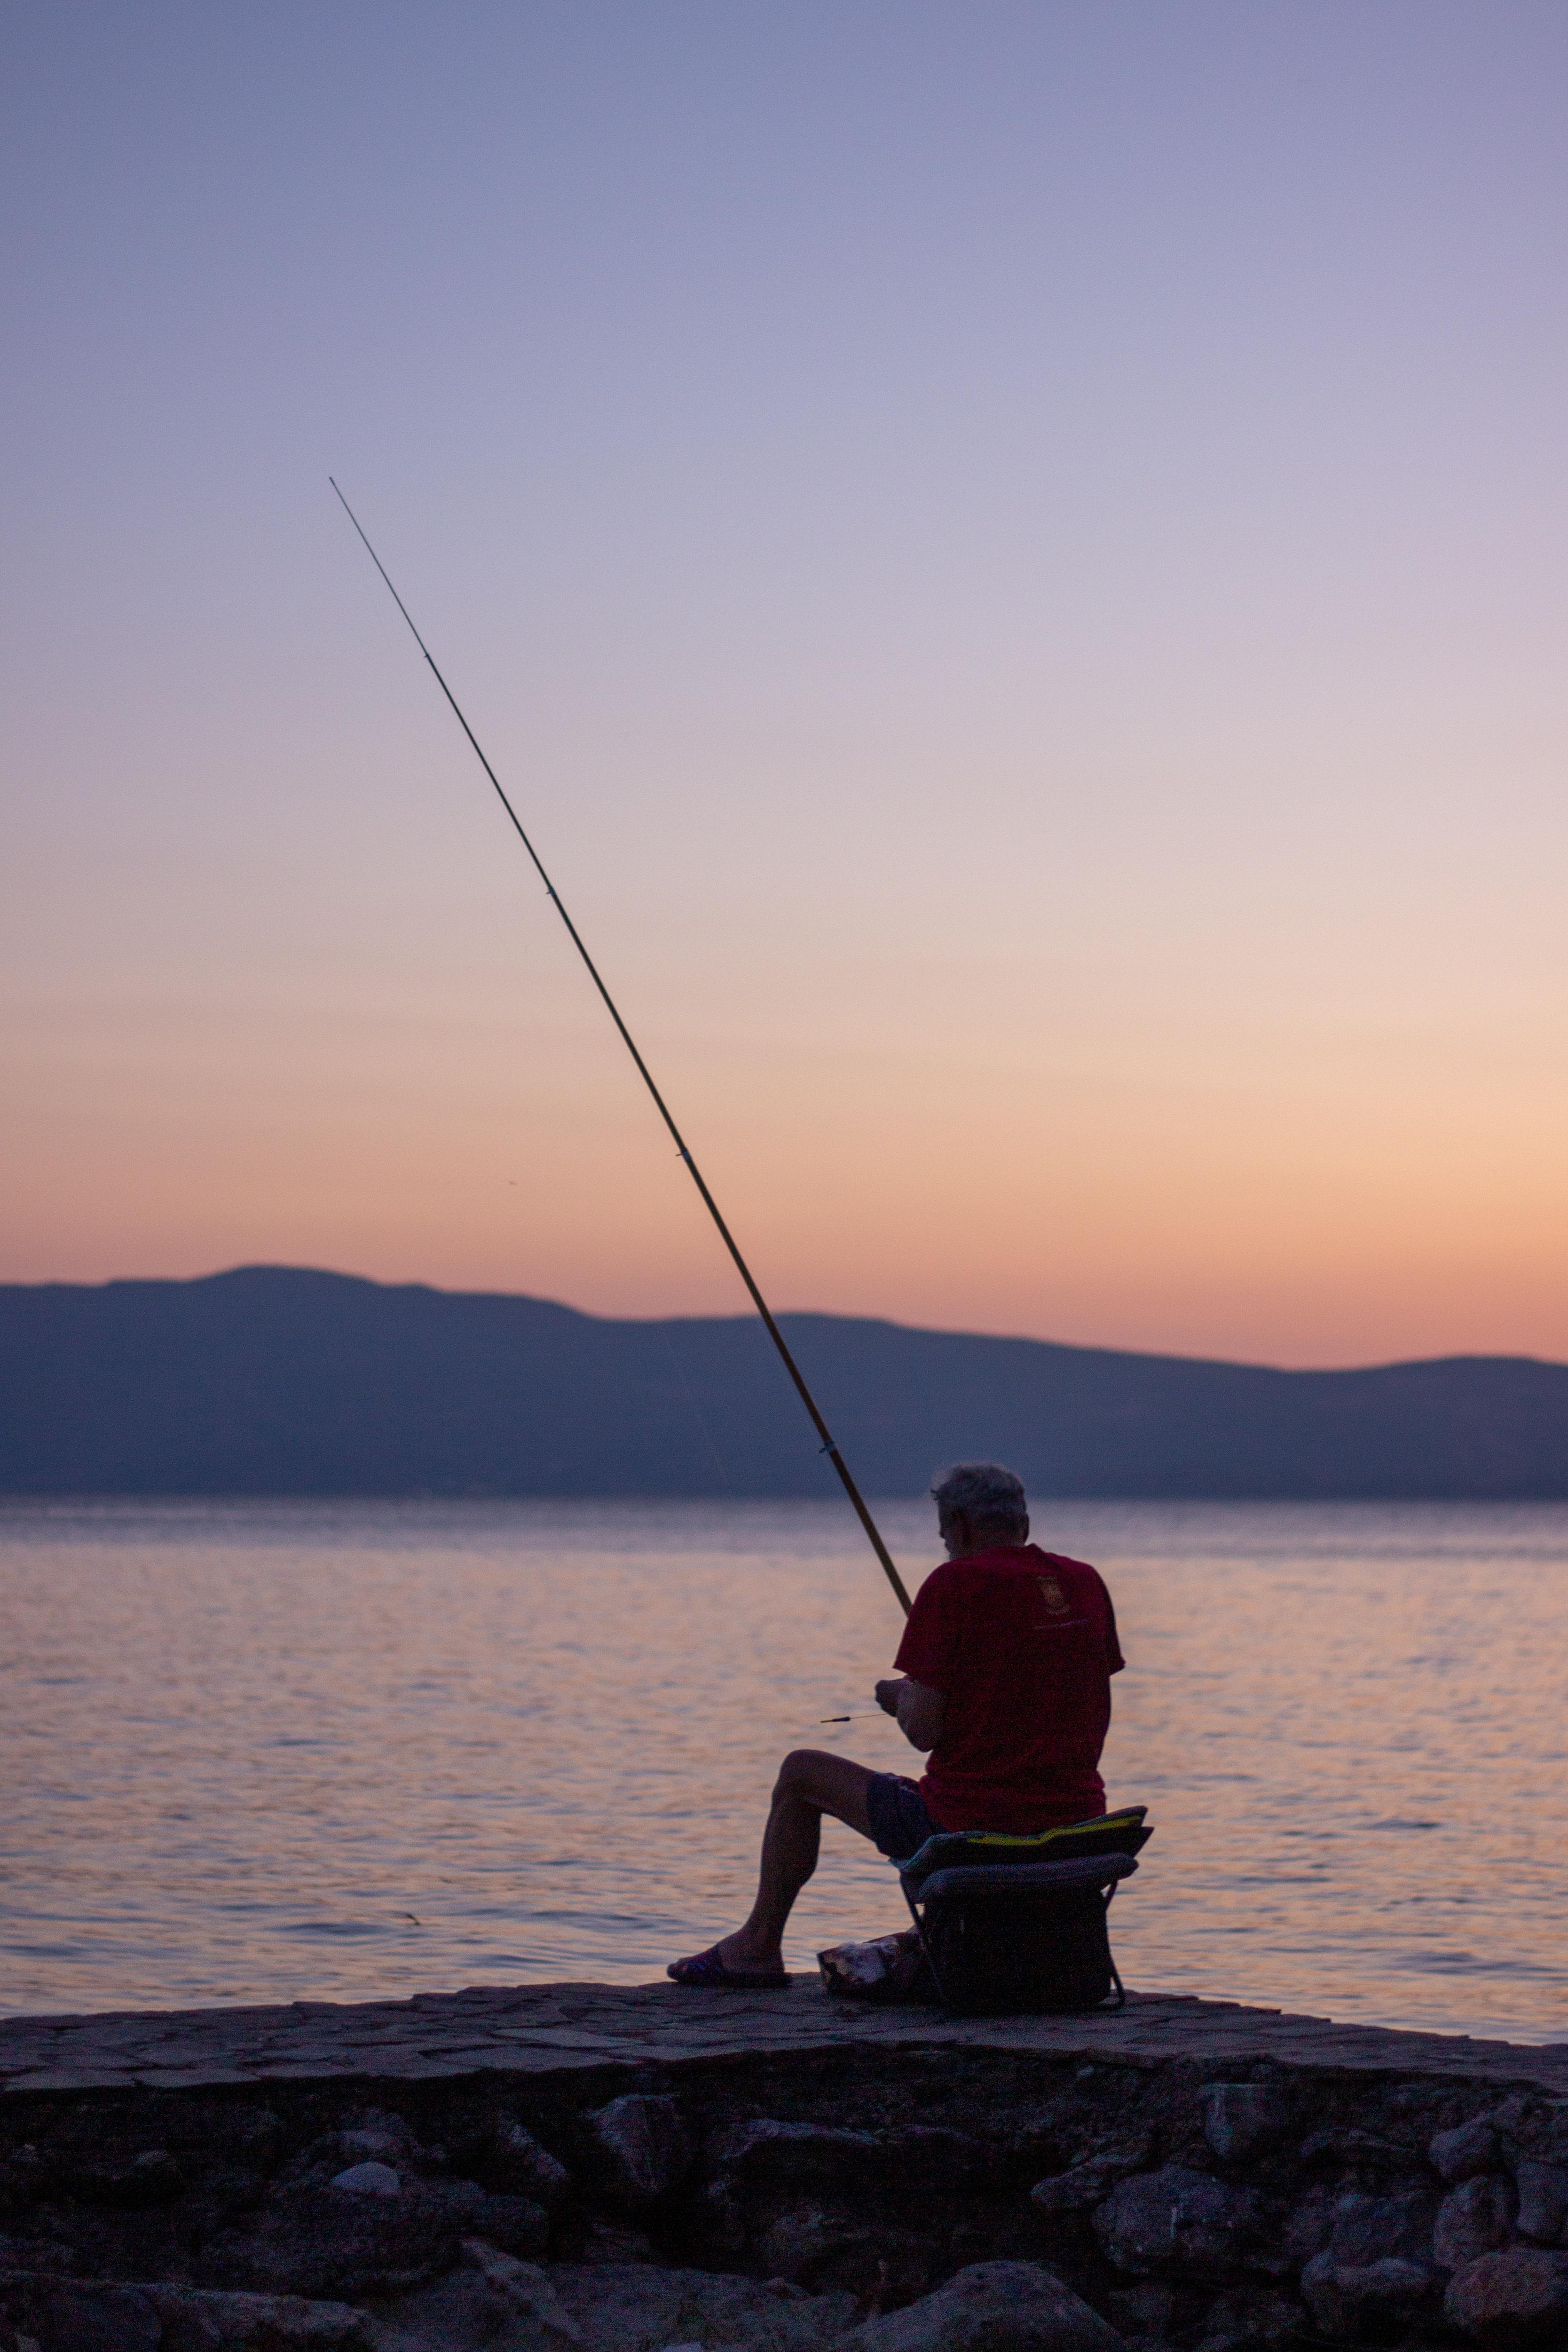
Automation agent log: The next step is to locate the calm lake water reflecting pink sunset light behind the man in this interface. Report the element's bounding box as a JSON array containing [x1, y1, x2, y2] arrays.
[[0, 1500, 1568, 2042]]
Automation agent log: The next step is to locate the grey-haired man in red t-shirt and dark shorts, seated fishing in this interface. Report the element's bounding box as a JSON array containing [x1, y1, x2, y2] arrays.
[[668, 1463, 1124, 1990]]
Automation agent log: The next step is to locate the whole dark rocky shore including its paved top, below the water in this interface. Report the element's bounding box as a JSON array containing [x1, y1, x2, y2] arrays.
[[0, 1981, 1568, 2352]]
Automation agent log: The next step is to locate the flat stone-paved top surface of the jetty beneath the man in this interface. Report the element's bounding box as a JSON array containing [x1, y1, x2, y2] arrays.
[[0, 1976, 1568, 2098]]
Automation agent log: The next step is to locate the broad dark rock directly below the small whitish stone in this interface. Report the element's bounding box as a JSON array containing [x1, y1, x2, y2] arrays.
[[195, 2185, 458, 2303]]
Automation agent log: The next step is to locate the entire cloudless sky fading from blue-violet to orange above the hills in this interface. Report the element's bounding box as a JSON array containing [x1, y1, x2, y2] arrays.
[[0, 0, 1568, 1364]]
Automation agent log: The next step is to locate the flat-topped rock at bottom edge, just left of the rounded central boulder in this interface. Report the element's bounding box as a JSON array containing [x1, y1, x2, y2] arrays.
[[541, 2263, 856, 2352]]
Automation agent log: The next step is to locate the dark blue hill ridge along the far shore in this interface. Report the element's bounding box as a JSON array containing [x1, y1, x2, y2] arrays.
[[0, 1265, 1568, 1500]]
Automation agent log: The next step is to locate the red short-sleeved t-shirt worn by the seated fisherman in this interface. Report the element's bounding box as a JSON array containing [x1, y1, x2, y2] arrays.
[[893, 1543, 1124, 1835]]
